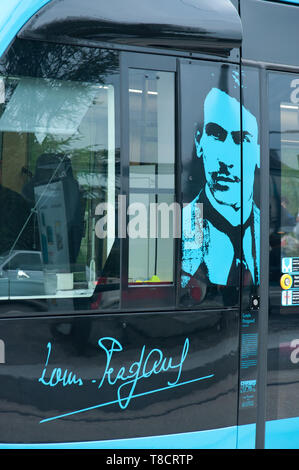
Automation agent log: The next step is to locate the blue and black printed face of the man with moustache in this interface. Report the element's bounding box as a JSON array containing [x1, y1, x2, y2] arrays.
[[196, 88, 259, 210]]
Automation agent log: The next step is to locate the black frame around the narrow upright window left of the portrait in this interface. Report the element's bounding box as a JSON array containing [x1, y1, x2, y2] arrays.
[[120, 52, 180, 310]]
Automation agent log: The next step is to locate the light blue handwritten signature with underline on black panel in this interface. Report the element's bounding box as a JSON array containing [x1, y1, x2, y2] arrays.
[[38, 336, 214, 422]]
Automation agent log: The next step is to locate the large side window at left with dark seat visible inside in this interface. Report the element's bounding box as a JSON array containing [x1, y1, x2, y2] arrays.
[[0, 43, 119, 310]]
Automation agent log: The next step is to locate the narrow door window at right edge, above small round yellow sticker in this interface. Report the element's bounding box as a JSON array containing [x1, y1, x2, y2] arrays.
[[270, 73, 299, 292]]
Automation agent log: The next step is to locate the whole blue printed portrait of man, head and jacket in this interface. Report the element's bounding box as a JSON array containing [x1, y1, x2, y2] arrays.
[[181, 87, 260, 287]]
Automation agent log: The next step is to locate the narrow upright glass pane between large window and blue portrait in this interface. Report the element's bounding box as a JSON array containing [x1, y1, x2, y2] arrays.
[[128, 69, 176, 285]]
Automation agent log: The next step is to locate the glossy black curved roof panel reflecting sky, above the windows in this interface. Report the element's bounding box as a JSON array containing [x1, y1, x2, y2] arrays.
[[21, 0, 242, 53]]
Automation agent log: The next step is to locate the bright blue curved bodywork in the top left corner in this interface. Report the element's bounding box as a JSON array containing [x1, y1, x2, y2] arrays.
[[0, 0, 51, 56]]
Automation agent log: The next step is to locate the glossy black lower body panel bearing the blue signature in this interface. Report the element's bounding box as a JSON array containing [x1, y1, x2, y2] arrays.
[[0, 311, 239, 445]]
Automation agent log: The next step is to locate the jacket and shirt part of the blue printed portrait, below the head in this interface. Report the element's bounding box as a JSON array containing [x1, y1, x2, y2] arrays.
[[181, 191, 260, 287]]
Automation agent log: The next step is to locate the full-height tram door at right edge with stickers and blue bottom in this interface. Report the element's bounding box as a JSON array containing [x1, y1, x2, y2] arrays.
[[265, 71, 299, 448]]
